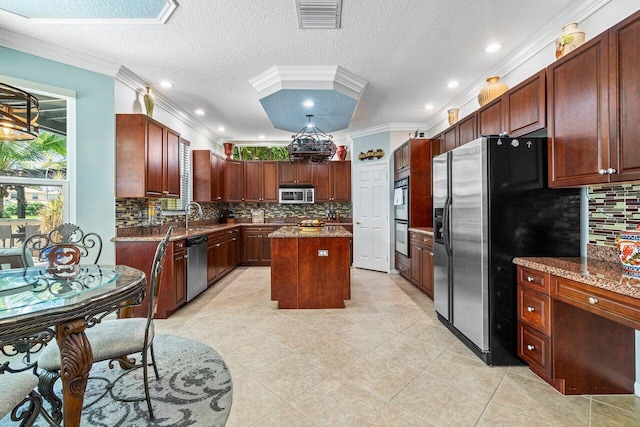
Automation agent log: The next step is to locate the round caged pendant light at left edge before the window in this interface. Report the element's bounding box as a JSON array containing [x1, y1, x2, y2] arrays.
[[0, 83, 40, 141]]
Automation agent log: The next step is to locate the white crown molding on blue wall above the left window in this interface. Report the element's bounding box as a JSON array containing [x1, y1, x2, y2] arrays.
[[0, 28, 120, 77]]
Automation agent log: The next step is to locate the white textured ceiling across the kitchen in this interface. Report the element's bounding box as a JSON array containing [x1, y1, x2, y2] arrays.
[[0, 0, 584, 145]]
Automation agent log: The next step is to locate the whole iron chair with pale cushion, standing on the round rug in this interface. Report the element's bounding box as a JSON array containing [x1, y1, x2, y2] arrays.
[[38, 227, 172, 422]]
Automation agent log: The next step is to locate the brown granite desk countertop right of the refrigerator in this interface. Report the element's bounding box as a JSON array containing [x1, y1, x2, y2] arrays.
[[513, 257, 640, 299]]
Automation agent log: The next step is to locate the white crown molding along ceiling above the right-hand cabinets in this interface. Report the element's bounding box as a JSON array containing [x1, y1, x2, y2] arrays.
[[421, 0, 611, 129]]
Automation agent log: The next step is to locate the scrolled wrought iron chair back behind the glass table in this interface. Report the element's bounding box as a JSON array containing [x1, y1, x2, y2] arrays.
[[22, 223, 102, 269]]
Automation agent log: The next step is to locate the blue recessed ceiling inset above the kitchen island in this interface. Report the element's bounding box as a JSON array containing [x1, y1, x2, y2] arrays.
[[260, 89, 358, 133]]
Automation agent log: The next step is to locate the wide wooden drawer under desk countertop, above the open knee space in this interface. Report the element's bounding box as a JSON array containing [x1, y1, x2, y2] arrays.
[[552, 276, 640, 329]]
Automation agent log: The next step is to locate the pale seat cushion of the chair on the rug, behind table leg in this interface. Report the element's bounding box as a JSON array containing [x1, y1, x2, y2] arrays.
[[38, 318, 154, 371]]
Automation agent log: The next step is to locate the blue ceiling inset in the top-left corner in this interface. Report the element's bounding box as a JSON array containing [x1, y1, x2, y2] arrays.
[[0, 0, 167, 19]]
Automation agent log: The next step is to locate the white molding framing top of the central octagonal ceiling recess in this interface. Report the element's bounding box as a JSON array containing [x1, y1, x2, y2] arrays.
[[249, 65, 368, 100]]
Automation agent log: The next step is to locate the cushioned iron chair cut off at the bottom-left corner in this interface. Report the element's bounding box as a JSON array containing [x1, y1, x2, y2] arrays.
[[0, 371, 42, 427]]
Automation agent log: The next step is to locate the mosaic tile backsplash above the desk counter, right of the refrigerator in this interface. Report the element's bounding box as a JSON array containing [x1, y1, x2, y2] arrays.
[[588, 183, 640, 246]]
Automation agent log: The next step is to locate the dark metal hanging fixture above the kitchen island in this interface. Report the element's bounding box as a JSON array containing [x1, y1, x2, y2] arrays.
[[287, 114, 336, 162]]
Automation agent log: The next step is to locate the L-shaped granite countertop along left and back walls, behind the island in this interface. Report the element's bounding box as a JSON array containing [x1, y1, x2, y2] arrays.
[[111, 221, 352, 242]]
